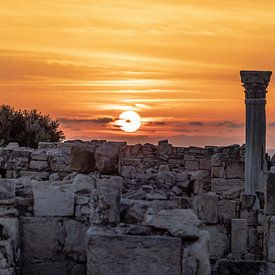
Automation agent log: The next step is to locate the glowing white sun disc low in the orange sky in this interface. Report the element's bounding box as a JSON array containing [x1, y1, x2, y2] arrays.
[[117, 111, 141, 133]]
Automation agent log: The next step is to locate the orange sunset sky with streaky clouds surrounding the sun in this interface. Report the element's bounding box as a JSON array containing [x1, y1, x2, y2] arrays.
[[0, 0, 275, 148]]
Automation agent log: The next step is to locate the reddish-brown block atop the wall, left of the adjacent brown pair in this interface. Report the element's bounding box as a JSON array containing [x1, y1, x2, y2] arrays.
[[70, 145, 95, 173]]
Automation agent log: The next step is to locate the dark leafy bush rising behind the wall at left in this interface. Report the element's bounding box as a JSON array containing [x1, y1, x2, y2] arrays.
[[0, 105, 65, 148]]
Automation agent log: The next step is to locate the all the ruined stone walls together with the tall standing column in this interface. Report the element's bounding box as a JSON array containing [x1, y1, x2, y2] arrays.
[[0, 71, 275, 275]]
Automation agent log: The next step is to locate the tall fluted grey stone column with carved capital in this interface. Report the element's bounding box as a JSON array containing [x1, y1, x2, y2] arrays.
[[241, 71, 272, 195]]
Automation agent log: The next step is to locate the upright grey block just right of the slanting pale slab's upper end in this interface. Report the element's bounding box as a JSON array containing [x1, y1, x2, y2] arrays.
[[203, 192, 219, 224]]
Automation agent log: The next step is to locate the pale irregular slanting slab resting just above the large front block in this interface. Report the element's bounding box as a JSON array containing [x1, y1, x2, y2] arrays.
[[143, 209, 201, 239]]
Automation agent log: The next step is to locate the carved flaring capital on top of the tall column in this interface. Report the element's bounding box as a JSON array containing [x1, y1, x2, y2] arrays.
[[240, 71, 272, 99]]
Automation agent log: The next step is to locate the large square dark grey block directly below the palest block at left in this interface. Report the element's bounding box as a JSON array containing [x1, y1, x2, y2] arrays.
[[22, 218, 58, 259]]
